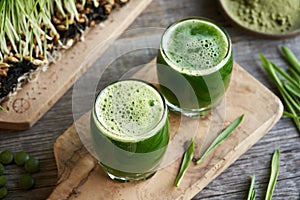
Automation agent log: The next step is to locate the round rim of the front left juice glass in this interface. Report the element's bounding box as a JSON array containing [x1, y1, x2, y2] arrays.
[[91, 78, 168, 142]]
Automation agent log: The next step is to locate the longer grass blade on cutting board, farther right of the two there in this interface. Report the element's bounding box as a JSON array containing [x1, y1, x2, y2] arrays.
[[196, 115, 244, 164]]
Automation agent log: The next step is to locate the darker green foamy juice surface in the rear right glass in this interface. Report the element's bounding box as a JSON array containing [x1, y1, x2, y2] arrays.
[[161, 19, 229, 75]]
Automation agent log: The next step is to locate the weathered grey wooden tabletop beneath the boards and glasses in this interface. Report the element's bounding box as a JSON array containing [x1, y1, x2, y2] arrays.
[[0, 0, 300, 200]]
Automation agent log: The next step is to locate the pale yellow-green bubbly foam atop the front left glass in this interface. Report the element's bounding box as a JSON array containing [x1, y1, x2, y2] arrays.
[[95, 80, 164, 142]]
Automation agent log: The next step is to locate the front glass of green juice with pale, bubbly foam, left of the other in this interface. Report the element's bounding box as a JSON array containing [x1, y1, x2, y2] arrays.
[[91, 79, 169, 182]]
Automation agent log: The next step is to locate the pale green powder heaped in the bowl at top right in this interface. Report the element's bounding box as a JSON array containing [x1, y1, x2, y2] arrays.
[[222, 0, 300, 34]]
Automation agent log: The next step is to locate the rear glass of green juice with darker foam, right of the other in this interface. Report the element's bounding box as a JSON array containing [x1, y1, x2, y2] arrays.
[[157, 17, 233, 117]]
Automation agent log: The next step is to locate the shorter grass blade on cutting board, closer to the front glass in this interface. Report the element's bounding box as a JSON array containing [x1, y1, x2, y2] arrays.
[[174, 139, 194, 187]]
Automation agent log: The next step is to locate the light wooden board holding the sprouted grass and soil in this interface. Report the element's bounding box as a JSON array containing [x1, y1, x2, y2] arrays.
[[0, 0, 152, 130]]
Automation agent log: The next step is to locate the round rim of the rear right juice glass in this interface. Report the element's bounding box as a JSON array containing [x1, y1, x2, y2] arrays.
[[159, 16, 232, 76]]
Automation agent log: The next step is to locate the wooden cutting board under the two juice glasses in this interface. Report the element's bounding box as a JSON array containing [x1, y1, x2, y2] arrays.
[[49, 62, 283, 200]]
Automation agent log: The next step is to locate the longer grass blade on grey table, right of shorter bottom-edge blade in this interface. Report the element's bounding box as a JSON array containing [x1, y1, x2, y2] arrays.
[[265, 149, 280, 200]]
